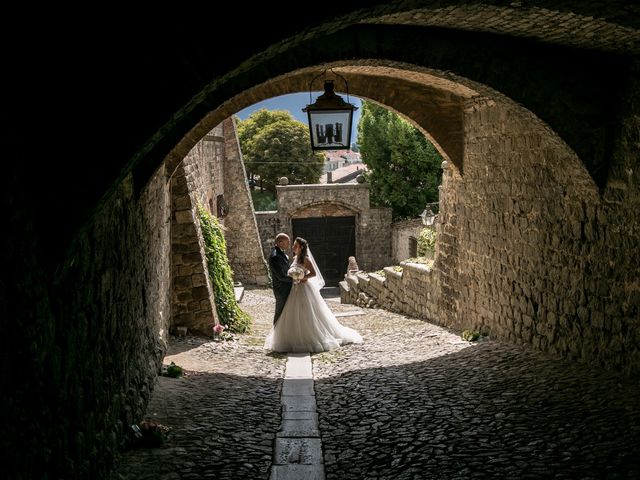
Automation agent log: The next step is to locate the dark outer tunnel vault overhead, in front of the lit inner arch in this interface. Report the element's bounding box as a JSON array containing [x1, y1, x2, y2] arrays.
[[7, 0, 640, 264]]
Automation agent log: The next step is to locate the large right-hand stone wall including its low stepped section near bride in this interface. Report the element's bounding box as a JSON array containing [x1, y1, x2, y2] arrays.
[[341, 94, 640, 373]]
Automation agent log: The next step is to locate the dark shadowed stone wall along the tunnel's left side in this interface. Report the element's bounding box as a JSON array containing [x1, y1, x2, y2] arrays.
[[8, 169, 171, 479]]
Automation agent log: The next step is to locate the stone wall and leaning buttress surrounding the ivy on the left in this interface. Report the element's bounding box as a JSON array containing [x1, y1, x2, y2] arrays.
[[171, 119, 268, 335]]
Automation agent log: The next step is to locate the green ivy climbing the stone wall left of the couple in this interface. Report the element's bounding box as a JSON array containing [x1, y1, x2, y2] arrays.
[[197, 205, 251, 333]]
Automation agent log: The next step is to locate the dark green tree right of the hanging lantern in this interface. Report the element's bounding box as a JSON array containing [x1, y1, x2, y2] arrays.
[[358, 101, 442, 219]]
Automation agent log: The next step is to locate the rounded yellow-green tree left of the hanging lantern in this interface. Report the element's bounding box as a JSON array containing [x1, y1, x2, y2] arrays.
[[236, 109, 324, 194]]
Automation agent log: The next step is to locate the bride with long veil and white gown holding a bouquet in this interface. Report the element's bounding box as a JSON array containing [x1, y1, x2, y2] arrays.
[[264, 237, 363, 353]]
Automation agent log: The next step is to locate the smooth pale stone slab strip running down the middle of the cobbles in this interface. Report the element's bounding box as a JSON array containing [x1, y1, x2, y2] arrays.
[[270, 353, 324, 480]]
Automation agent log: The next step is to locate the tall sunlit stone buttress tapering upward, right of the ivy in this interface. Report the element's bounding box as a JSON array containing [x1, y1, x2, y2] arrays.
[[223, 118, 269, 285]]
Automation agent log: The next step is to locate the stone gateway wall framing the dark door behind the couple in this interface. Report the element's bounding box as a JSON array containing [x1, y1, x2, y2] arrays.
[[256, 184, 391, 282]]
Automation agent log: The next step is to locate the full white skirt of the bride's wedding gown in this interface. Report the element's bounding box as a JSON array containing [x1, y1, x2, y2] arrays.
[[264, 270, 363, 353]]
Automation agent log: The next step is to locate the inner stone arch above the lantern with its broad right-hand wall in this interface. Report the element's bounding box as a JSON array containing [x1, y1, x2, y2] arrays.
[[167, 54, 636, 374]]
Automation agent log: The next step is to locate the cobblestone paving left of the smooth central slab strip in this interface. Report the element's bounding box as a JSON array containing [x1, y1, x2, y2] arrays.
[[113, 290, 285, 480]]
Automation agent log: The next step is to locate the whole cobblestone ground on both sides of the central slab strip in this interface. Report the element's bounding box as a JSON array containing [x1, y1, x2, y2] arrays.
[[113, 289, 640, 480]]
